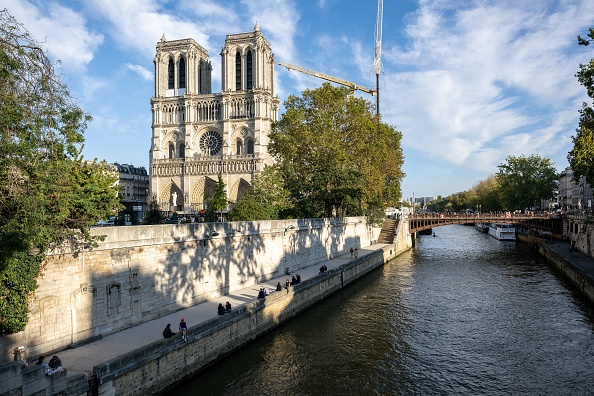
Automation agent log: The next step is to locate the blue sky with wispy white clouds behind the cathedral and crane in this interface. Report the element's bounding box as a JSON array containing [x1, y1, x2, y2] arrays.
[[0, 0, 594, 198]]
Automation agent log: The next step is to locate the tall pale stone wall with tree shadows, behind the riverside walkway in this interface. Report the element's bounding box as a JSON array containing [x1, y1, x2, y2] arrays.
[[0, 217, 379, 363]]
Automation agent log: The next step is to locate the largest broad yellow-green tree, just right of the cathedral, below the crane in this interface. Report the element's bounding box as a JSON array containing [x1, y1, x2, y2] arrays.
[[268, 83, 404, 217]]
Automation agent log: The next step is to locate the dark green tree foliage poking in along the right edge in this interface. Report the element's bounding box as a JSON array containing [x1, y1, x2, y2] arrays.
[[567, 28, 594, 185]]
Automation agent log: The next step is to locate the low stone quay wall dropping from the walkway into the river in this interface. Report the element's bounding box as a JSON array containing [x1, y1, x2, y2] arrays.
[[93, 243, 411, 396]]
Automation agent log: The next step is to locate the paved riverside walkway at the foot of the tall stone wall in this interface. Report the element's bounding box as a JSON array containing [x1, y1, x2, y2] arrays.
[[52, 244, 386, 376]]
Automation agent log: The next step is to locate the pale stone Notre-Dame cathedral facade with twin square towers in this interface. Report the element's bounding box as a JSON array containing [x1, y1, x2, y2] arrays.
[[150, 24, 279, 213]]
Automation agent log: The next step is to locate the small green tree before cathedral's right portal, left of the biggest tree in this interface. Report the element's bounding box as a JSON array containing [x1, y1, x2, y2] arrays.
[[227, 166, 293, 221]]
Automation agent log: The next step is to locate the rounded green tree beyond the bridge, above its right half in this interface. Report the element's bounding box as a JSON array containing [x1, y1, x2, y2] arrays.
[[497, 155, 559, 210]]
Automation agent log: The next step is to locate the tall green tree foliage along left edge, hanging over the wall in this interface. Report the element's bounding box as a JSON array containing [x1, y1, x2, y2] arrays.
[[0, 10, 119, 334]]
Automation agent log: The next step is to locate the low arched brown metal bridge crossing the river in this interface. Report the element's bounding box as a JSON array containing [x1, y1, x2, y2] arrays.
[[405, 213, 563, 234]]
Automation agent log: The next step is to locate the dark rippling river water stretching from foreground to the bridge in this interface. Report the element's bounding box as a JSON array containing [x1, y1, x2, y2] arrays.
[[170, 225, 594, 396]]
